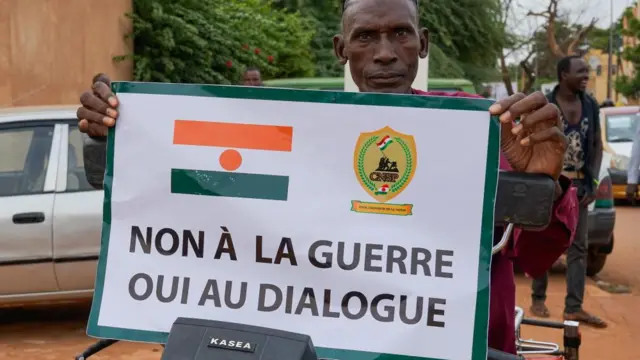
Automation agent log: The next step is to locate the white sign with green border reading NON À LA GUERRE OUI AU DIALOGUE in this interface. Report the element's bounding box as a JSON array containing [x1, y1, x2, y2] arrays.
[[88, 82, 499, 360]]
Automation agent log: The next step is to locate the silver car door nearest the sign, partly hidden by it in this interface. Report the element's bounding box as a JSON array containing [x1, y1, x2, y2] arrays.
[[53, 121, 103, 291]]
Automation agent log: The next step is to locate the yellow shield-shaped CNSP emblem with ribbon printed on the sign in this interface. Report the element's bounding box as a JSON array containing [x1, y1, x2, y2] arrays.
[[351, 126, 417, 215]]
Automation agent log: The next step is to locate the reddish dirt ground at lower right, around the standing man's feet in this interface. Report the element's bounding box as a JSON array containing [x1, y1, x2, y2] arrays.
[[517, 206, 640, 360]]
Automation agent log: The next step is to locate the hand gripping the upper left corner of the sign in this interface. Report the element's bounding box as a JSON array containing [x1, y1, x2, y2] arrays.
[[76, 74, 119, 137]]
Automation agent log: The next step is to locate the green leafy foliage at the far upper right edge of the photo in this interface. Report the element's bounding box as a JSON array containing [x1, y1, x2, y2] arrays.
[[615, 8, 640, 99]]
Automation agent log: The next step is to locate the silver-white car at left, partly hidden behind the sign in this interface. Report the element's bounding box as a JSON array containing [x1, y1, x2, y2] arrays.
[[0, 106, 103, 306]]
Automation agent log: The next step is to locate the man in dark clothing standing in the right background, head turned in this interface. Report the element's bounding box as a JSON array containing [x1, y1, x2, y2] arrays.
[[531, 56, 607, 328]]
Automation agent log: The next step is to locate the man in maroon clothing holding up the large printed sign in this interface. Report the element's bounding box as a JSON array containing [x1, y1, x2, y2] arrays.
[[77, 0, 577, 353]]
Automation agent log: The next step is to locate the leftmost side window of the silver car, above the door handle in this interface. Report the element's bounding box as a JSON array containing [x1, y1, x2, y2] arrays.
[[0, 125, 53, 196]]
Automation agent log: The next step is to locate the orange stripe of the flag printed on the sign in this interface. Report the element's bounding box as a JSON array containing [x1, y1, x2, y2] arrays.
[[173, 120, 293, 151]]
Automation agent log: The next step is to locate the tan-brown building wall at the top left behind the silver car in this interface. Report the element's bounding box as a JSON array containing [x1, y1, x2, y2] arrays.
[[0, 0, 132, 107]]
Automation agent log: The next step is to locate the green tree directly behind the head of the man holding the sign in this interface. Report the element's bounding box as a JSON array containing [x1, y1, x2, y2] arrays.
[[274, 0, 503, 82]]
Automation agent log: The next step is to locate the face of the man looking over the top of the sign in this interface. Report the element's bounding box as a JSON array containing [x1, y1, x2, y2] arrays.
[[333, 0, 428, 93]]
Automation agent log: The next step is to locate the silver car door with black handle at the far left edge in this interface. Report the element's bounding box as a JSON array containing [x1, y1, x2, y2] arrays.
[[0, 121, 60, 298]]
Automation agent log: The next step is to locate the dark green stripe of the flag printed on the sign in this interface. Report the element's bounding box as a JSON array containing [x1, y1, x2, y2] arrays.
[[171, 169, 289, 201]]
